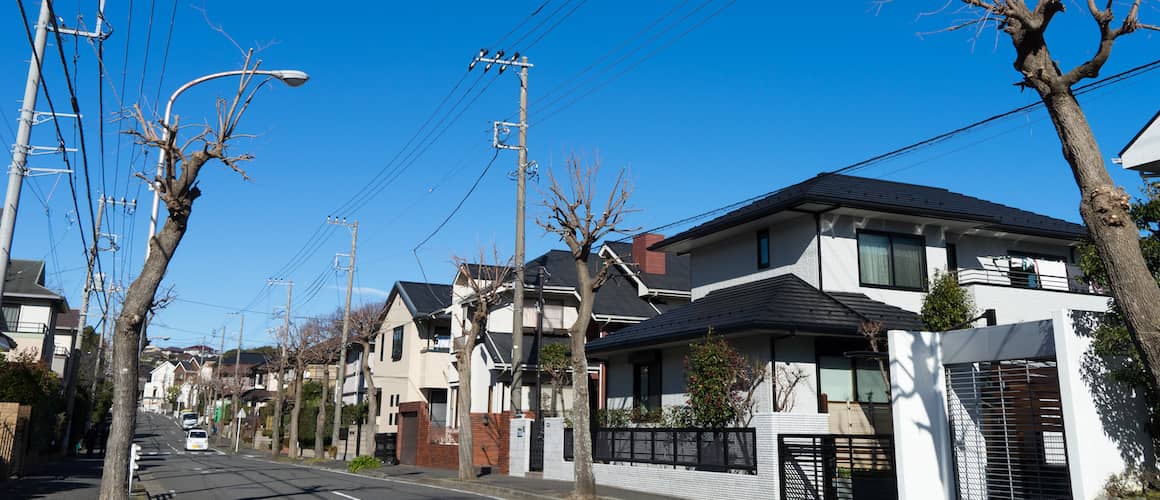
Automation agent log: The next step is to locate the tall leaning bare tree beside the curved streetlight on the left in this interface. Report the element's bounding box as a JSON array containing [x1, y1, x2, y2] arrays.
[[100, 51, 273, 500]]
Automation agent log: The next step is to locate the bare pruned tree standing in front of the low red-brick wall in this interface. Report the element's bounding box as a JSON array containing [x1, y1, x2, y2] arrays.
[[451, 249, 512, 481]]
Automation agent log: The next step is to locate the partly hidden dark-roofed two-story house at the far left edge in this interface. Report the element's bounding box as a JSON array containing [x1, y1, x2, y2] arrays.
[[0, 259, 73, 376]]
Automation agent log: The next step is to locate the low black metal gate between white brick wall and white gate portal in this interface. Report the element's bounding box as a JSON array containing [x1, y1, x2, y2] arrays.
[[777, 434, 898, 500]]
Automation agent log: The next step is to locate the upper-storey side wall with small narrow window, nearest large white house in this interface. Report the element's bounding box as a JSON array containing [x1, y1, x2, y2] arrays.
[[689, 215, 818, 300]]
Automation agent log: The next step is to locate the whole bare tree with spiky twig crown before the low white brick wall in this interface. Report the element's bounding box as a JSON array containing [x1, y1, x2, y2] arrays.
[[536, 157, 636, 499]]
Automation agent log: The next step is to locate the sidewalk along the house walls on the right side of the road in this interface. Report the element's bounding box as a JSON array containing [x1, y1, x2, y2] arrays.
[[249, 452, 672, 500]]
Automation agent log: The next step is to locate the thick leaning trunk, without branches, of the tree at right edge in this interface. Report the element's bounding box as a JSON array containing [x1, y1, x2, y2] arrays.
[[1041, 89, 1160, 390]]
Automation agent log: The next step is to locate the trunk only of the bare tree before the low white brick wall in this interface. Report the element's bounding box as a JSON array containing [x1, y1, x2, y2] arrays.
[[568, 259, 596, 500]]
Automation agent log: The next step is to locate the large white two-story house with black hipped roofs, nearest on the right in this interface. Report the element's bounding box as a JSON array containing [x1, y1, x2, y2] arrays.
[[588, 174, 1108, 433]]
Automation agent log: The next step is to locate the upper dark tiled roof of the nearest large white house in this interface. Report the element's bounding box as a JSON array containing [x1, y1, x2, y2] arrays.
[[653, 174, 1087, 248]]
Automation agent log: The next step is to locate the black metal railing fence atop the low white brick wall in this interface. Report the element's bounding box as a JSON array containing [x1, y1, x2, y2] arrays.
[[564, 427, 757, 473]]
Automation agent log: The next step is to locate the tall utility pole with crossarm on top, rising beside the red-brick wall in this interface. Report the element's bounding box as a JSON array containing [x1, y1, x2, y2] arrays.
[[467, 49, 535, 416]]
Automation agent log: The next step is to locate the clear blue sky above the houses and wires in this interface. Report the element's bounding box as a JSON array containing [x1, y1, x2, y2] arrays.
[[0, 0, 1160, 346]]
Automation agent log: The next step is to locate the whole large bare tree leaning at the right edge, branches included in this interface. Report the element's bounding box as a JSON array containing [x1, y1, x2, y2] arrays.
[[900, 0, 1160, 389]]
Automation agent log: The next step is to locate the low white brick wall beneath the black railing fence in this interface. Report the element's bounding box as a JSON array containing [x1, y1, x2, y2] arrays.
[[544, 413, 829, 499]]
